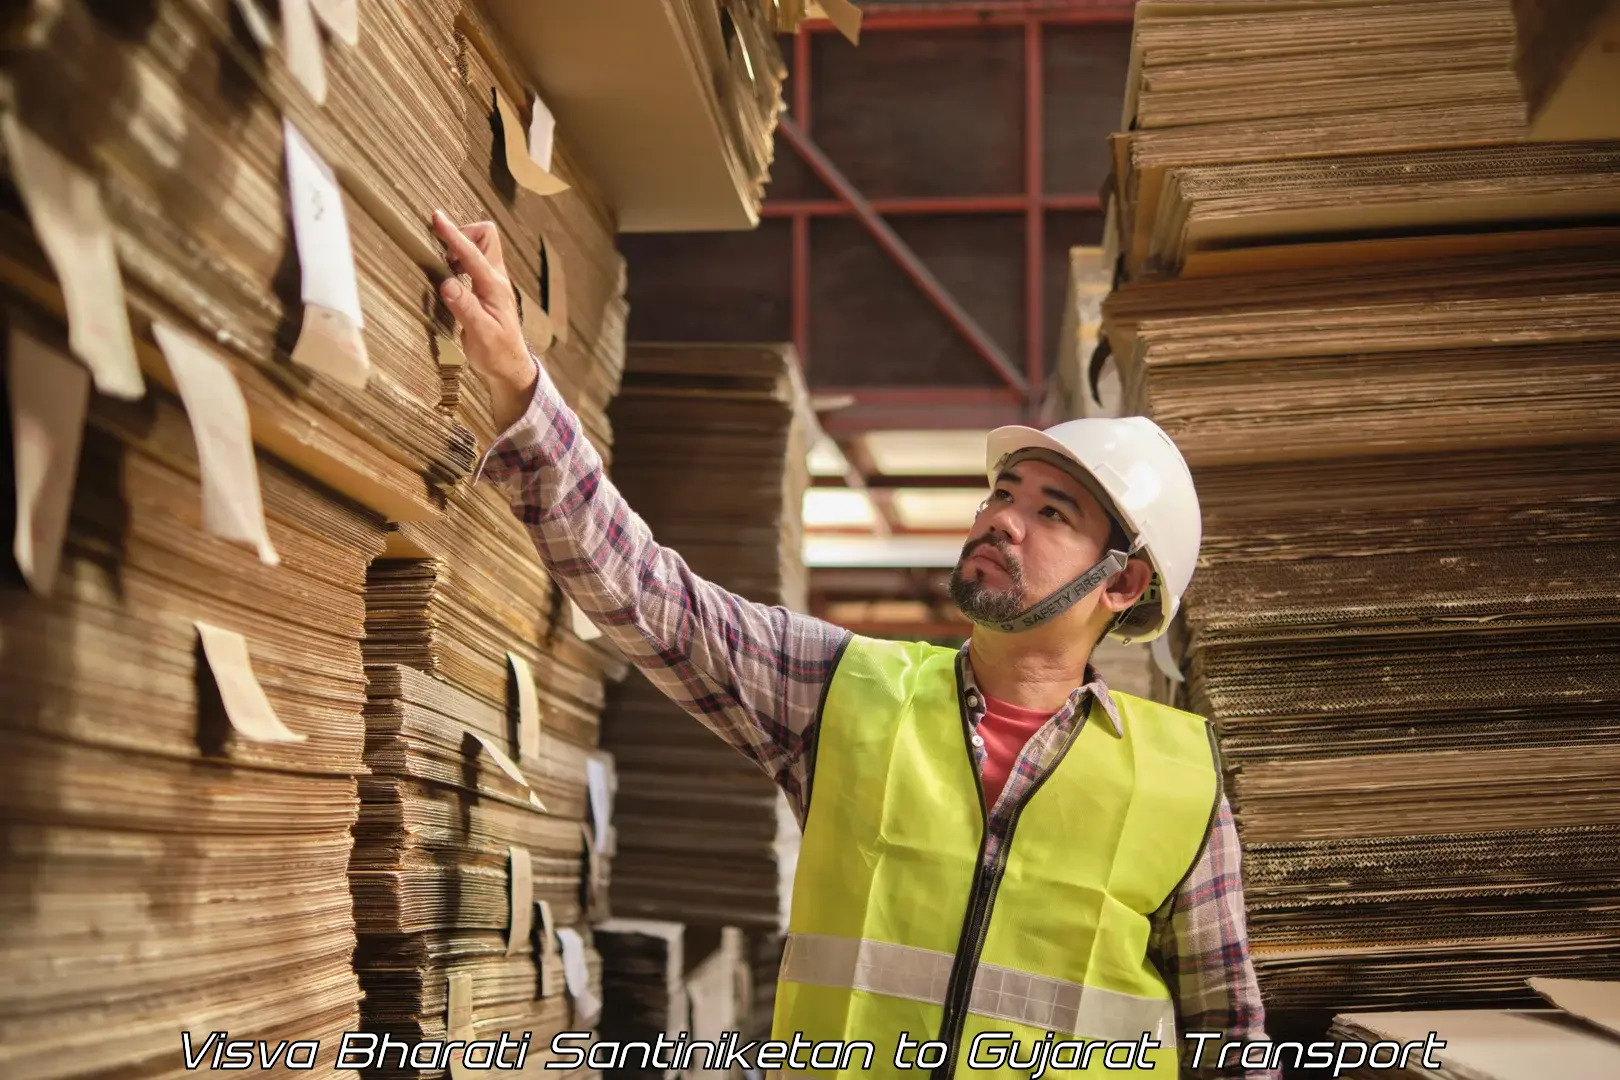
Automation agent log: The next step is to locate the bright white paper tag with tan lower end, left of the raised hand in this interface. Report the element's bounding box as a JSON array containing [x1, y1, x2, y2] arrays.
[[284, 120, 371, 389]]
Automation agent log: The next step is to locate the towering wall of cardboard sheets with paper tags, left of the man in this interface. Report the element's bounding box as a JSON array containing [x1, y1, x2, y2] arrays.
[[0, 0, 624, 1078]]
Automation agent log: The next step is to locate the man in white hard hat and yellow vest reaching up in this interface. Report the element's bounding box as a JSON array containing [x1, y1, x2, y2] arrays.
[[434, 214, 1278, 1077]]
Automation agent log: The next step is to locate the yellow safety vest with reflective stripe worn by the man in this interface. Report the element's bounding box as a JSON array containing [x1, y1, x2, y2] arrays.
[[770, 636, 1220, 1080]]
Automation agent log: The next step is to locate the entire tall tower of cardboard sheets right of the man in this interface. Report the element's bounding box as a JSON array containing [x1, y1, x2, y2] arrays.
[[1105, 0, 1620, 1015]]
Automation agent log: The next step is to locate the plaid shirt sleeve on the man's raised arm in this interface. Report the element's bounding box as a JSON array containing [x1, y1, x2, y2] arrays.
[[475, 363, 847, 808]]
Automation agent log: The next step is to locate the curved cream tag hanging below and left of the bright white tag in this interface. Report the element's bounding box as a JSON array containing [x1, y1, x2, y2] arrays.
[[152, 322, 280, 567]]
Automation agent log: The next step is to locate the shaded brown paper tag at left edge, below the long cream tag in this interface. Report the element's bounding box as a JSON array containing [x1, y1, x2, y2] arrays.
[[6, 330, 91, 596]]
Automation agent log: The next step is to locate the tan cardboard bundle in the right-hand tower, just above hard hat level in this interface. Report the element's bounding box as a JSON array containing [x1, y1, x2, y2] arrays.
[[1110, 241, 1620, 466]]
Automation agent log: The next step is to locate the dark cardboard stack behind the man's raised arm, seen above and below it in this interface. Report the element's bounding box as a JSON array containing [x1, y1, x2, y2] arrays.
[[603, 345, 813, 928]]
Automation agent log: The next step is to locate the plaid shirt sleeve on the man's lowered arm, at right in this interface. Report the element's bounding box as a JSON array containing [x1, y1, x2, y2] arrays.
[[1150, 795, 1283, 1080]]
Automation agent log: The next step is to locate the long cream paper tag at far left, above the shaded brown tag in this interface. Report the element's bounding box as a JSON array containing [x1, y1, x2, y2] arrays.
[[0, 112, 146, 402]]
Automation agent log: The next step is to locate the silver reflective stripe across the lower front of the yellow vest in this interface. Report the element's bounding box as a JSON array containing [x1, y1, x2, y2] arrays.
[[781, 934, 1176, 1041]]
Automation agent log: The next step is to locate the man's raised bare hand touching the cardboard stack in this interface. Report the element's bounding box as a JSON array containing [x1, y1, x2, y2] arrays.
[[433, 210, 538, 431]]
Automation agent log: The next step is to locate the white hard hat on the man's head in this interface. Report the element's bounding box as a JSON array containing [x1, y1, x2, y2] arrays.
[[985, 416, 1204, 643]]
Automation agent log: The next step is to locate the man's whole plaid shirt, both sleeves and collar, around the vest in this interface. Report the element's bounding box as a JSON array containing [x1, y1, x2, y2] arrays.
[[475, 366, 1281, 1080]]
